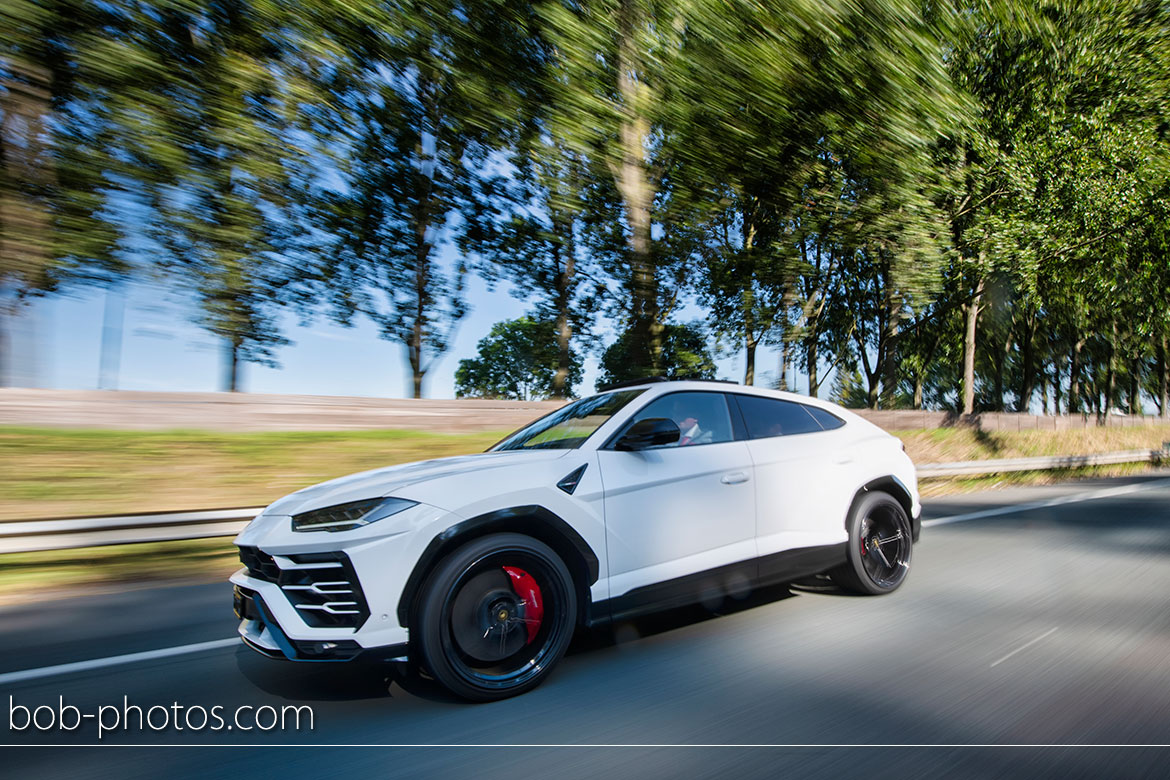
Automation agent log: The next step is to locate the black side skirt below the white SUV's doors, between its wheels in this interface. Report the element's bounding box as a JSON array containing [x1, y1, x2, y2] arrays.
[[587, 541, 847, 627]]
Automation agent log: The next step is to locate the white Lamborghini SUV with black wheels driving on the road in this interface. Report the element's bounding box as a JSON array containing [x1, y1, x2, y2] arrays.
[[232, 381, 921, 700]]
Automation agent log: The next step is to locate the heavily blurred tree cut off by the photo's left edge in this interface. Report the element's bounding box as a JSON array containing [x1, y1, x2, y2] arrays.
[[0, 0, 149, 385]]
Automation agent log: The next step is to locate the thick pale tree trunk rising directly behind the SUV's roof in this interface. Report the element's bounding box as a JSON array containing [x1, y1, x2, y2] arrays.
[[614, 0, 663, 377]]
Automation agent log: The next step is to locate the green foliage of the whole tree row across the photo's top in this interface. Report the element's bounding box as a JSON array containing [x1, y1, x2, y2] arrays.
[[0, 0, 1170, 414]]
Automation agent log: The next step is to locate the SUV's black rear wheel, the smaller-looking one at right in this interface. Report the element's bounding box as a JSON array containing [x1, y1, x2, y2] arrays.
[[831, 491, 914, 595]]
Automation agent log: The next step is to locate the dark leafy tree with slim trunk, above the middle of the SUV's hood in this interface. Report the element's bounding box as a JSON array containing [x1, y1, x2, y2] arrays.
[[311, 0, 543, 398]]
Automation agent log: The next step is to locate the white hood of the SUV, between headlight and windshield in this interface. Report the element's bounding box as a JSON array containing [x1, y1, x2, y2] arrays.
[[264, 449, 570, 515]]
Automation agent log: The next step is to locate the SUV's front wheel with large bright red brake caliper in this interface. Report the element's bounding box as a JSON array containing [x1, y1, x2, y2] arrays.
[[411, 533, 577, 702]]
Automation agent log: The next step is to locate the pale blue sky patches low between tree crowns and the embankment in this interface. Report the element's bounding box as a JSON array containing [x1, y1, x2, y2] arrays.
[[14, 265, 803, 399]]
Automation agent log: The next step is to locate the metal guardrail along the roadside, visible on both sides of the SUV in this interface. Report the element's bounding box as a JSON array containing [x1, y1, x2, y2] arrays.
[[0, 442, 1170, 553]]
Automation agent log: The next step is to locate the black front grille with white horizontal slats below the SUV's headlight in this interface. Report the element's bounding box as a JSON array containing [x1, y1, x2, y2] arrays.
[[232, 546, 370, 629]]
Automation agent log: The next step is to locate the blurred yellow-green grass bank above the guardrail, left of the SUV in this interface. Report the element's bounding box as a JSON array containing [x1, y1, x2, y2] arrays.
[[0, 427, 502, 519]]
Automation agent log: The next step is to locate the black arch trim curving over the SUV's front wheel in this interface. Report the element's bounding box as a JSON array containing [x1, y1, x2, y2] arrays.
[[398, 505, 600, 626]]
